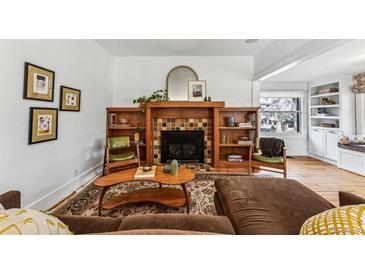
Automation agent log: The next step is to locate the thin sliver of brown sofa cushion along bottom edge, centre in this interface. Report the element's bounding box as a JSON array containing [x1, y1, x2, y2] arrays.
[[94, 229, 218, 235]]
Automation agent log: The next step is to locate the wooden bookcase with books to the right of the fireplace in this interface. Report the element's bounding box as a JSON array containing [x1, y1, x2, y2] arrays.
[[214, 108, 258, 168]]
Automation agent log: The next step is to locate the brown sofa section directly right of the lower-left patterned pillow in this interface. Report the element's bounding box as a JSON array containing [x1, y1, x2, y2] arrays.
[[54, 215, 122, 234]]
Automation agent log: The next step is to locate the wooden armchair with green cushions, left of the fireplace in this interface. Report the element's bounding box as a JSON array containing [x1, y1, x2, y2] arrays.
[[104, 136, 140, 175]]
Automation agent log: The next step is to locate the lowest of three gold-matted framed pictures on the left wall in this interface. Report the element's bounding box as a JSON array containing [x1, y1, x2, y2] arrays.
[[28, 107, 58, 145]]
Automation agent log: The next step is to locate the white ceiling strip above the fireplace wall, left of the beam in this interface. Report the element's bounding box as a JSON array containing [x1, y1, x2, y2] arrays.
[[96, 39, 274, 56]]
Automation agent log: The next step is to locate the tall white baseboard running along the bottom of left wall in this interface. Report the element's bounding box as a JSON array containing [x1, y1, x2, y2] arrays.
[[25, 163, 103, 210]]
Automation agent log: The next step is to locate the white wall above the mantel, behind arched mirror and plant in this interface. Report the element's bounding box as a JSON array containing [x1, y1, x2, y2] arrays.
[[113, 56, 258, 106]]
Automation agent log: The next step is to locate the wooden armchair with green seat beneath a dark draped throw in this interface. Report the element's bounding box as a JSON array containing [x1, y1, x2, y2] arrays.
[[251, 138, 287, 178]]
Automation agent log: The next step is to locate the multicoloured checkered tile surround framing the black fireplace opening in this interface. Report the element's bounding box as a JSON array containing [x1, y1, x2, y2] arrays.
[[153, 118, 212, 164]]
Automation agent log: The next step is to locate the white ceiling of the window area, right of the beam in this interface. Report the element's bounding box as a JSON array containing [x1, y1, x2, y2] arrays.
[[265, 39, 365, 82]]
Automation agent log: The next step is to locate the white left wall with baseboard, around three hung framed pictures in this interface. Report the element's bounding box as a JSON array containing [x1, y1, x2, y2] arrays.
[[0, 40, 113, 209]]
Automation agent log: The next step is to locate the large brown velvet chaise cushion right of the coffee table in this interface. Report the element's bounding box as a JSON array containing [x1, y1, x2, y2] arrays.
[[215, 176, 334, 235]]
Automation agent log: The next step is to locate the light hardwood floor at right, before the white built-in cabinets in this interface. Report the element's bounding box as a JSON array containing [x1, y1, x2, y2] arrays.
[[260, 157, 365, 205]]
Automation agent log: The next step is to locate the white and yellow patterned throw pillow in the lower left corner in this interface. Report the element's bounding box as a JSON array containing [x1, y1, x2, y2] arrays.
[[0, 208, 73, 235]]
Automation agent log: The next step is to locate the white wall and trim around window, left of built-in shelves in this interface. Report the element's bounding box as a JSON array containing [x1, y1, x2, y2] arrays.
[[260, 82, 308, 156]]
